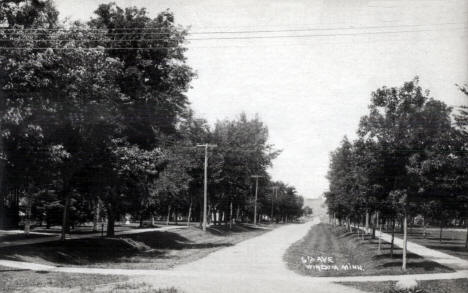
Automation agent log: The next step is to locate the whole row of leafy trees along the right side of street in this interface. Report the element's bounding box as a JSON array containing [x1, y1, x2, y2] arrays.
[[325, 78, 468, 269]]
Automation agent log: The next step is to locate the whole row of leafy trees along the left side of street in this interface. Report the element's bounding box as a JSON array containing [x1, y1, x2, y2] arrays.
[[0, 0, 303, 238]]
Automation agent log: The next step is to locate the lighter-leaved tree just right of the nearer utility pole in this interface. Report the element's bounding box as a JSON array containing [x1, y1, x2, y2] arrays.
[[212, 113, 279, 222]]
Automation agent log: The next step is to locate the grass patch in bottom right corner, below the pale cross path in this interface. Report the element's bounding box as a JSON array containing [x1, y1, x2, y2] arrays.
[[339, 279, 468, 293]]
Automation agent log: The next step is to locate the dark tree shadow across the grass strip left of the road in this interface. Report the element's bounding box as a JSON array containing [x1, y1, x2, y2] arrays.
[[0, 231, 231, 265]]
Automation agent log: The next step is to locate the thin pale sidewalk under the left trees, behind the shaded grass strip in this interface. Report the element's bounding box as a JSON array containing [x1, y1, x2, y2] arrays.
[[0, 226, 187, 248]]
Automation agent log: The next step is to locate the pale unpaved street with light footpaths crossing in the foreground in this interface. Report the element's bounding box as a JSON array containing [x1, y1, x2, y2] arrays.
[[0, 218, 468, 292]]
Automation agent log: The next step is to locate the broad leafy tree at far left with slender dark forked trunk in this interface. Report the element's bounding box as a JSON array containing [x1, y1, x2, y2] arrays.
[[2, 23, 126, 238]]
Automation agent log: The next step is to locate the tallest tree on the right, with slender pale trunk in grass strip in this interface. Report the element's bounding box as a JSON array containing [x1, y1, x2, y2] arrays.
[[359, 78, 451, 270]]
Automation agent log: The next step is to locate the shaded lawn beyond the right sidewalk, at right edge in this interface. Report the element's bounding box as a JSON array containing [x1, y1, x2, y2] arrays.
[[395, 227, 468, 259]]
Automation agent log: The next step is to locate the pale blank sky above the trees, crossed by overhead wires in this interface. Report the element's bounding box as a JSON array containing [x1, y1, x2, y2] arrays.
[[55, 0, 468, 198]]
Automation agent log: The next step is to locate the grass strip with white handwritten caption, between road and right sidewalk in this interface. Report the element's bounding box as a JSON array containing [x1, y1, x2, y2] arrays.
[[284, 223, 453, 276]]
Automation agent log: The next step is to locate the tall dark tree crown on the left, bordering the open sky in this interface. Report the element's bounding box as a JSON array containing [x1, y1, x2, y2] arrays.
[[89, 3, 195, 149]]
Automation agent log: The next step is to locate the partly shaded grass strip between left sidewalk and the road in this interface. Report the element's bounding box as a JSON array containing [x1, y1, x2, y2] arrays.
[[0, 225, 268, 269]]
